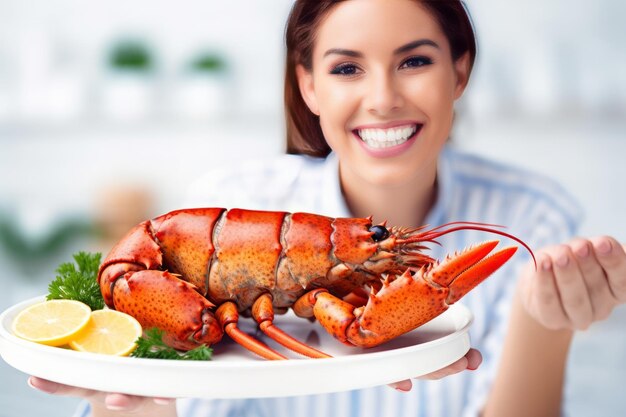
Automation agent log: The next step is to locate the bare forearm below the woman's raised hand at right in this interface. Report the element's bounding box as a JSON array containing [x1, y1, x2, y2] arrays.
[[483, 290, 573, 417]]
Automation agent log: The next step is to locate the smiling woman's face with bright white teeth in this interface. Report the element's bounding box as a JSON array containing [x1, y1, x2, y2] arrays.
[[297, 0, 469, 185]]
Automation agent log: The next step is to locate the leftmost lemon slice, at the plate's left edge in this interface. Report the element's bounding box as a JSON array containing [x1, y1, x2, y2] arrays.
[[12, 300, 91, 346]]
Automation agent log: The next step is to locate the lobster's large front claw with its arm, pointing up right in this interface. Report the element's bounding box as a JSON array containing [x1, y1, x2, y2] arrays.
[[294, 241, 517, 347]]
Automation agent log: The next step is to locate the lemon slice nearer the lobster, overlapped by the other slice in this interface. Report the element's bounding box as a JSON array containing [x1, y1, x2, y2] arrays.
[[69, 310, 141, 356]]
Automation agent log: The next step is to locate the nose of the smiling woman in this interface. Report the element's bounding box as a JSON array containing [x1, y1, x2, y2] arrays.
[[365, 71, 404, 116]]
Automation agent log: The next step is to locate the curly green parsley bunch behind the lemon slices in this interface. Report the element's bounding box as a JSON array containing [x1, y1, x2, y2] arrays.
[[46, 252, 104, 311]]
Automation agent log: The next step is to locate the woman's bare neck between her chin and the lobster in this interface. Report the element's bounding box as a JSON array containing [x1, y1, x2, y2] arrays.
[[339, 162, 437, 227]]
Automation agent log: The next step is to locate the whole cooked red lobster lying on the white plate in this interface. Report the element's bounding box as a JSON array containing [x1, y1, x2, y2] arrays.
[[98, 208, 532, 359]]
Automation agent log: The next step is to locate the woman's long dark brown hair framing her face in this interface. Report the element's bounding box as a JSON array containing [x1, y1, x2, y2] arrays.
[[285, 0, 476, 157]]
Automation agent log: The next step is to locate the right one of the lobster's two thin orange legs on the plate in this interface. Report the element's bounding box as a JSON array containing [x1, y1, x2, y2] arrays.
[[252, 293, 331, 358]]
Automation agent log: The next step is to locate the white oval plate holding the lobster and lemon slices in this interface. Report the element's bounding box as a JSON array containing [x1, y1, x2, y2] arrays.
[[0, 297, 473, 398]]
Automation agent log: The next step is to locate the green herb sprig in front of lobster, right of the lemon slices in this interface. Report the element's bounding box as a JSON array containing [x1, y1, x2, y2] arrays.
[[130, 327, 213, 361]]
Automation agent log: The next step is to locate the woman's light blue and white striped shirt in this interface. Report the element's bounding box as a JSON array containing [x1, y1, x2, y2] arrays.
[[72, 144, 581, 417]]
